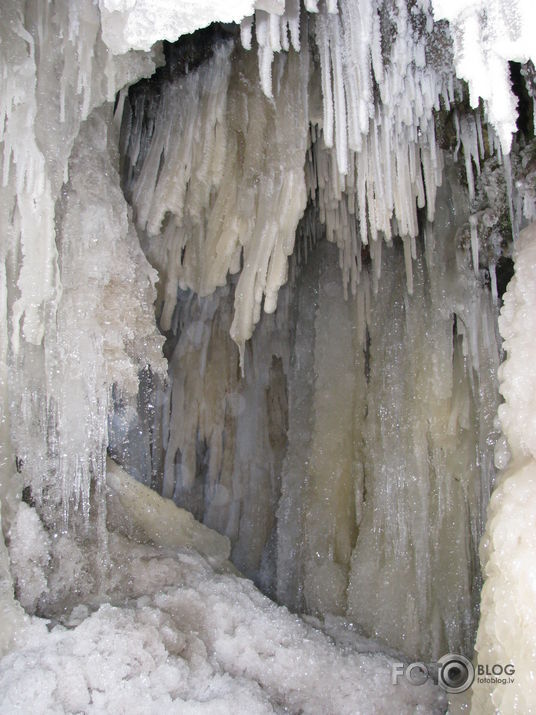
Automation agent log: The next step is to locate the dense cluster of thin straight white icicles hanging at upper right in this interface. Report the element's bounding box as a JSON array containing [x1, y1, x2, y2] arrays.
[[308, 0, 454, 292]]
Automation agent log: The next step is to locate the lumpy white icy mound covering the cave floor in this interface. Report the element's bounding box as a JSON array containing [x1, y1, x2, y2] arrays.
[[0, 470, 445, 715]]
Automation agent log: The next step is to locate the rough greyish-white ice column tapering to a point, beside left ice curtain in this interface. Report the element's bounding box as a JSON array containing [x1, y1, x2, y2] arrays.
[[32, 105, 165, 512]]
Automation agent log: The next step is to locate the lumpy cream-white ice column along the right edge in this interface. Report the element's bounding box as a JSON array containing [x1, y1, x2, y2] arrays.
[[472, 224, 536, 713]]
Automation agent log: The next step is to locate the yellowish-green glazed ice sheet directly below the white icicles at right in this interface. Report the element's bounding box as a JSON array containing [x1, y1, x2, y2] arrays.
[[277, 196, 498, 657]]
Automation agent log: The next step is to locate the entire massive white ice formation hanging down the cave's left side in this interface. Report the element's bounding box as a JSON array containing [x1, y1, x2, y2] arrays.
[[0, 1, 163, 532]]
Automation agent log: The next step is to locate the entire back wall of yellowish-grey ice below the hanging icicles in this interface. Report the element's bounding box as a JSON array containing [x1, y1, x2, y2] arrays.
[[141, 172, 499, 655]]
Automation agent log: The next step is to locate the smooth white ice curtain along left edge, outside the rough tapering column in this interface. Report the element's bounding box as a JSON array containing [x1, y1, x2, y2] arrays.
[[0, 0, 164, 524]]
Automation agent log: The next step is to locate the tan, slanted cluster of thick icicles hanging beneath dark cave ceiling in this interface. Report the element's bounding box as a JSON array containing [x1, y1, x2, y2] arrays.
[[123, 44, 309, 360]]
